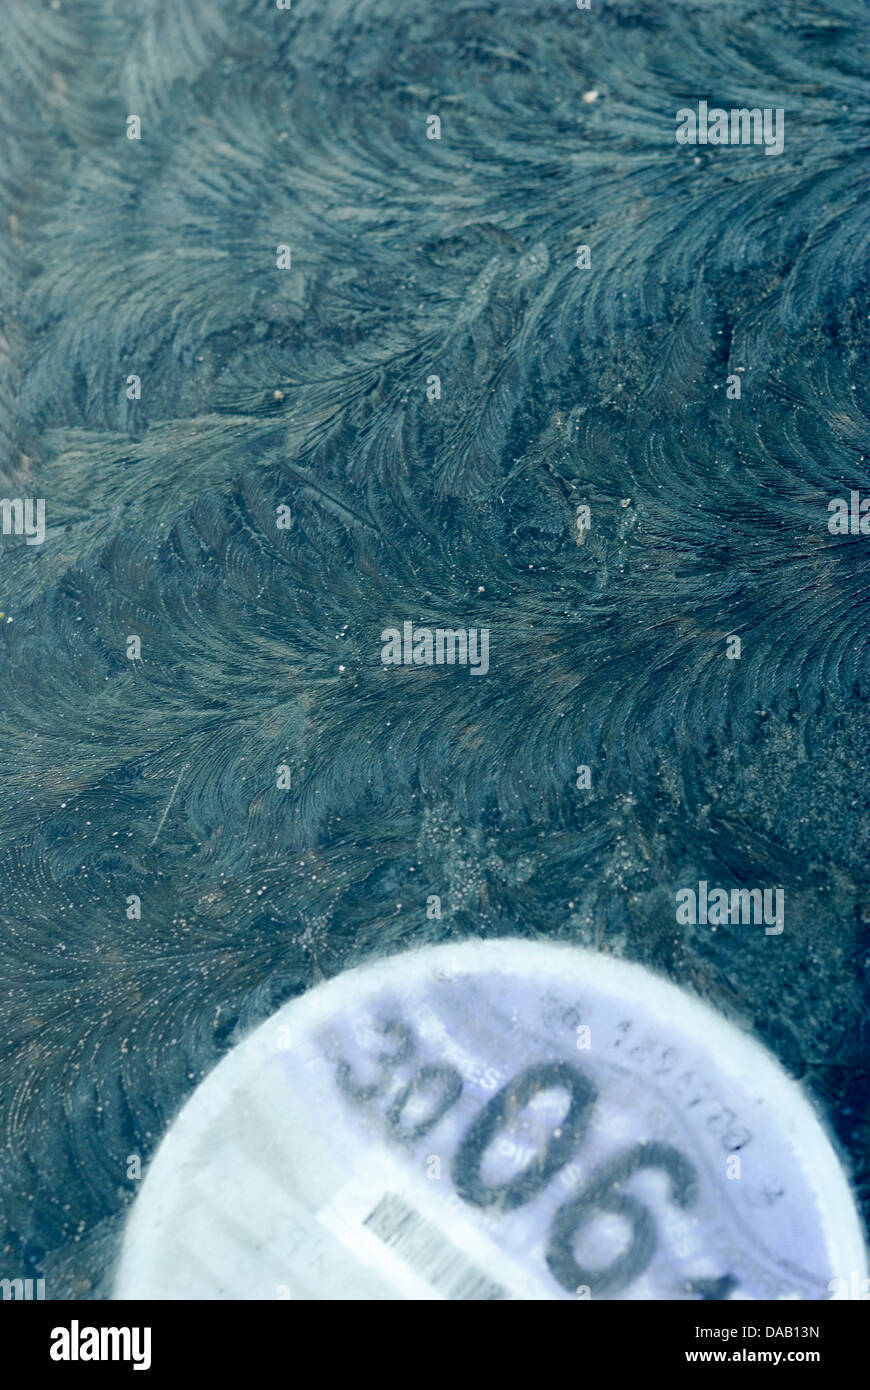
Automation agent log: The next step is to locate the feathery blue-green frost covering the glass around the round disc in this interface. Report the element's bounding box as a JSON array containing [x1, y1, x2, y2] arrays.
[[0, 0, 870, 1298]]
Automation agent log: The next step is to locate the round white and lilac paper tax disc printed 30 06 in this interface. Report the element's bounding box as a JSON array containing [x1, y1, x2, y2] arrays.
[[115, 940, 870, 1300]]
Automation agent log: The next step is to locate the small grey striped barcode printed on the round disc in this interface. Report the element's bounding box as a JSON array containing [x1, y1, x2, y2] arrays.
[[363, 1193, 510, 1300]]
